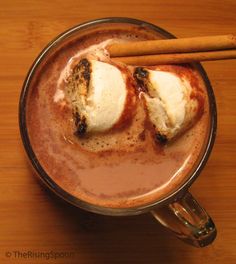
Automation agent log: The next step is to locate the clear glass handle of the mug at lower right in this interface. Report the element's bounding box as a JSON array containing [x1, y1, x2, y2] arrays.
[[151, 192, 217, 247]]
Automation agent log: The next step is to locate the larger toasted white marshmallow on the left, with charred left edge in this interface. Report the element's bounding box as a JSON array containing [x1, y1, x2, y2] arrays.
[[67, 59, 127, 135]]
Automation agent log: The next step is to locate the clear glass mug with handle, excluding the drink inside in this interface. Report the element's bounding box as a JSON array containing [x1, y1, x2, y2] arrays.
[[19, 18, 217, 247]]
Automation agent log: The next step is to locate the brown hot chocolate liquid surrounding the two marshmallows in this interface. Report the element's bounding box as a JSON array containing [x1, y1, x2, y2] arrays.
[[26, 24, 209, 208]]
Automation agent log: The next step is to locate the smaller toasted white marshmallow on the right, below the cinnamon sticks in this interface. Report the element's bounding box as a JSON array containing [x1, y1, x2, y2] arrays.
[[134, 67, 202, 143]]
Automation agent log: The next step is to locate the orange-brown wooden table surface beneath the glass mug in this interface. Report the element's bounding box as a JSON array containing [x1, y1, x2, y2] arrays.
[[0, 0, 236, 264]]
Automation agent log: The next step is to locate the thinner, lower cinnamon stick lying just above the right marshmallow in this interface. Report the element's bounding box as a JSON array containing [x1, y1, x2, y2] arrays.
[[112, 49, 236, 66]]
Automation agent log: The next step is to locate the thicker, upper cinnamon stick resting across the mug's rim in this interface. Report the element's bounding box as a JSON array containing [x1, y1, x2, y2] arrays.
[[107, 34, 236, 57]]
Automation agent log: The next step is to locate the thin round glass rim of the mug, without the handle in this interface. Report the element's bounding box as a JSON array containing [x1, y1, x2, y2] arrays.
[[18, 17, 217, 216]]
